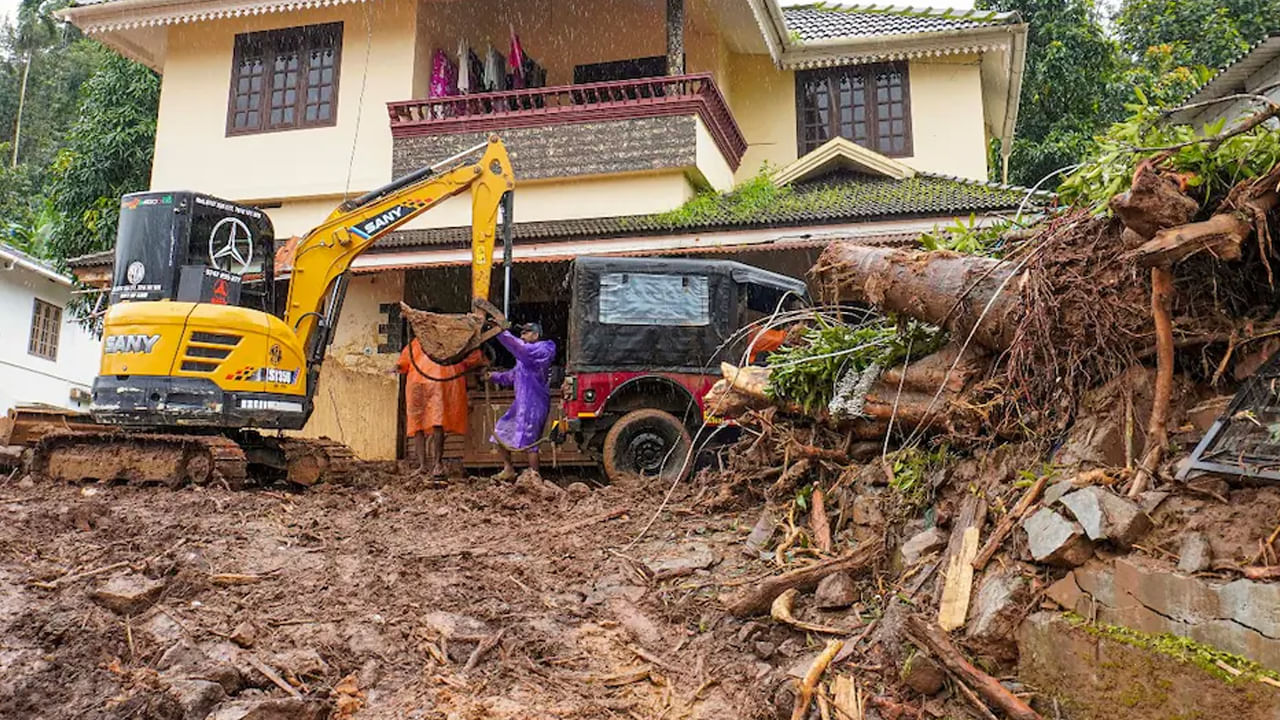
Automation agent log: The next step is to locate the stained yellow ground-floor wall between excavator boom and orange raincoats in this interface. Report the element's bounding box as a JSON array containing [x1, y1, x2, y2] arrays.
[[301, 272, 404, 460]]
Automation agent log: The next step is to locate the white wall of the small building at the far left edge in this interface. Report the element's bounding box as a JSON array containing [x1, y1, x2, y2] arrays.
[[0, 265, 101, 413]]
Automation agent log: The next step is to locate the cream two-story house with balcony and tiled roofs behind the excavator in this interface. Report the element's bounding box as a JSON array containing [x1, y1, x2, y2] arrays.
[[63, 0, 1027, 457]]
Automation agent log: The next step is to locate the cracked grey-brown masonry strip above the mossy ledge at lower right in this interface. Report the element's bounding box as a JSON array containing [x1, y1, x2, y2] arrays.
[[1047, 557, 1280, 670]]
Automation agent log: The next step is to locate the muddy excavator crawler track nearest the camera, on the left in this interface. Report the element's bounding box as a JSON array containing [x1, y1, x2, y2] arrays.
[[31, 430, 248, 489]]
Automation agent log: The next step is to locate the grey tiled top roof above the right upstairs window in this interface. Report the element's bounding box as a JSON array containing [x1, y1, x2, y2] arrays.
[[782, 3, 1016, 42]]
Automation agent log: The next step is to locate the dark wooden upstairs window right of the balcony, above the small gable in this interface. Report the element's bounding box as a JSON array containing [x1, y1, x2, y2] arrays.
[[796, 63, 911, 156]]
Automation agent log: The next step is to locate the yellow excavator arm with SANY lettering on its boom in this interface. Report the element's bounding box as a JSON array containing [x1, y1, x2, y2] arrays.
[[284, 136, 516, 363]]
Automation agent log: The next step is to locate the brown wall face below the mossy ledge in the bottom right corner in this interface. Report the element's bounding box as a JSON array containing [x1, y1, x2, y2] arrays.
[[1018, 612, 1280, 720]]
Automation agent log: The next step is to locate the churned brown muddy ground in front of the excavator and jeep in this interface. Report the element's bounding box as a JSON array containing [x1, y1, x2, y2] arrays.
[[0, 465, 875, 720]]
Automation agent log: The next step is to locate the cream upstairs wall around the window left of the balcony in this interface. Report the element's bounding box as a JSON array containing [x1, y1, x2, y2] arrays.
[[151, 0, 419, 201]]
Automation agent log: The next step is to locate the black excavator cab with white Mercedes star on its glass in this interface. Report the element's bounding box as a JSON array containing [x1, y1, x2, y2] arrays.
[[110, 192, 275, 313]]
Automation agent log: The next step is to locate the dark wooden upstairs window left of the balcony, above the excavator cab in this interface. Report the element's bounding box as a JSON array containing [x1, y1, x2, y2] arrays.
[[227, 23, 342, 135]]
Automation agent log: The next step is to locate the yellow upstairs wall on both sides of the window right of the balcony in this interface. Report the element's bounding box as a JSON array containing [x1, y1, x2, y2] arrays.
[[727, 54, 987, 182]]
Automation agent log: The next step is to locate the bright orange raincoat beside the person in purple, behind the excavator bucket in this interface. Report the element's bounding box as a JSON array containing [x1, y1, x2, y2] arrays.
[[396, 340, 484, 436]]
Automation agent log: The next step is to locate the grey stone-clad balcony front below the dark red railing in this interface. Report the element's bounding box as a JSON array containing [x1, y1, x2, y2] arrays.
[[392, 114, 698, 182]]
